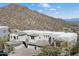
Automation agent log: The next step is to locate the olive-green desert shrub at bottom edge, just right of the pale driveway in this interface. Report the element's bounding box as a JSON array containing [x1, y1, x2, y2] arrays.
[[38, 46, 61, 56]]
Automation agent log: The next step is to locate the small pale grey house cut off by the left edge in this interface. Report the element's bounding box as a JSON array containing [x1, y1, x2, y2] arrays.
[[0, 26, 10, 39]]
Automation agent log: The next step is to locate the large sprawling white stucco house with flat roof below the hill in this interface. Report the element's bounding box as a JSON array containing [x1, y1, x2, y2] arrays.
[[10, 30, 77, 46]]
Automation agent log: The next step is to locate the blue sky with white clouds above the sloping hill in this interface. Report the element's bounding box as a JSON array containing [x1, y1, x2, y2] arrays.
[[0, 3, 79, 19]]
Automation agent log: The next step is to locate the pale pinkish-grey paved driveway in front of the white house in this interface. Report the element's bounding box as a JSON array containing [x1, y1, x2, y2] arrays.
[[9, 44, 36, 56]]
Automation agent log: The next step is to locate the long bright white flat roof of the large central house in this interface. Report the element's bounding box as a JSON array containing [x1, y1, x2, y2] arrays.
[[10, 30, 77, 37]]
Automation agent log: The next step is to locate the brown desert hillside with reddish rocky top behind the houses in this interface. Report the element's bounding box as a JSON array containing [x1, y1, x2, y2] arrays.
[[0, 4, 64, 31]]
